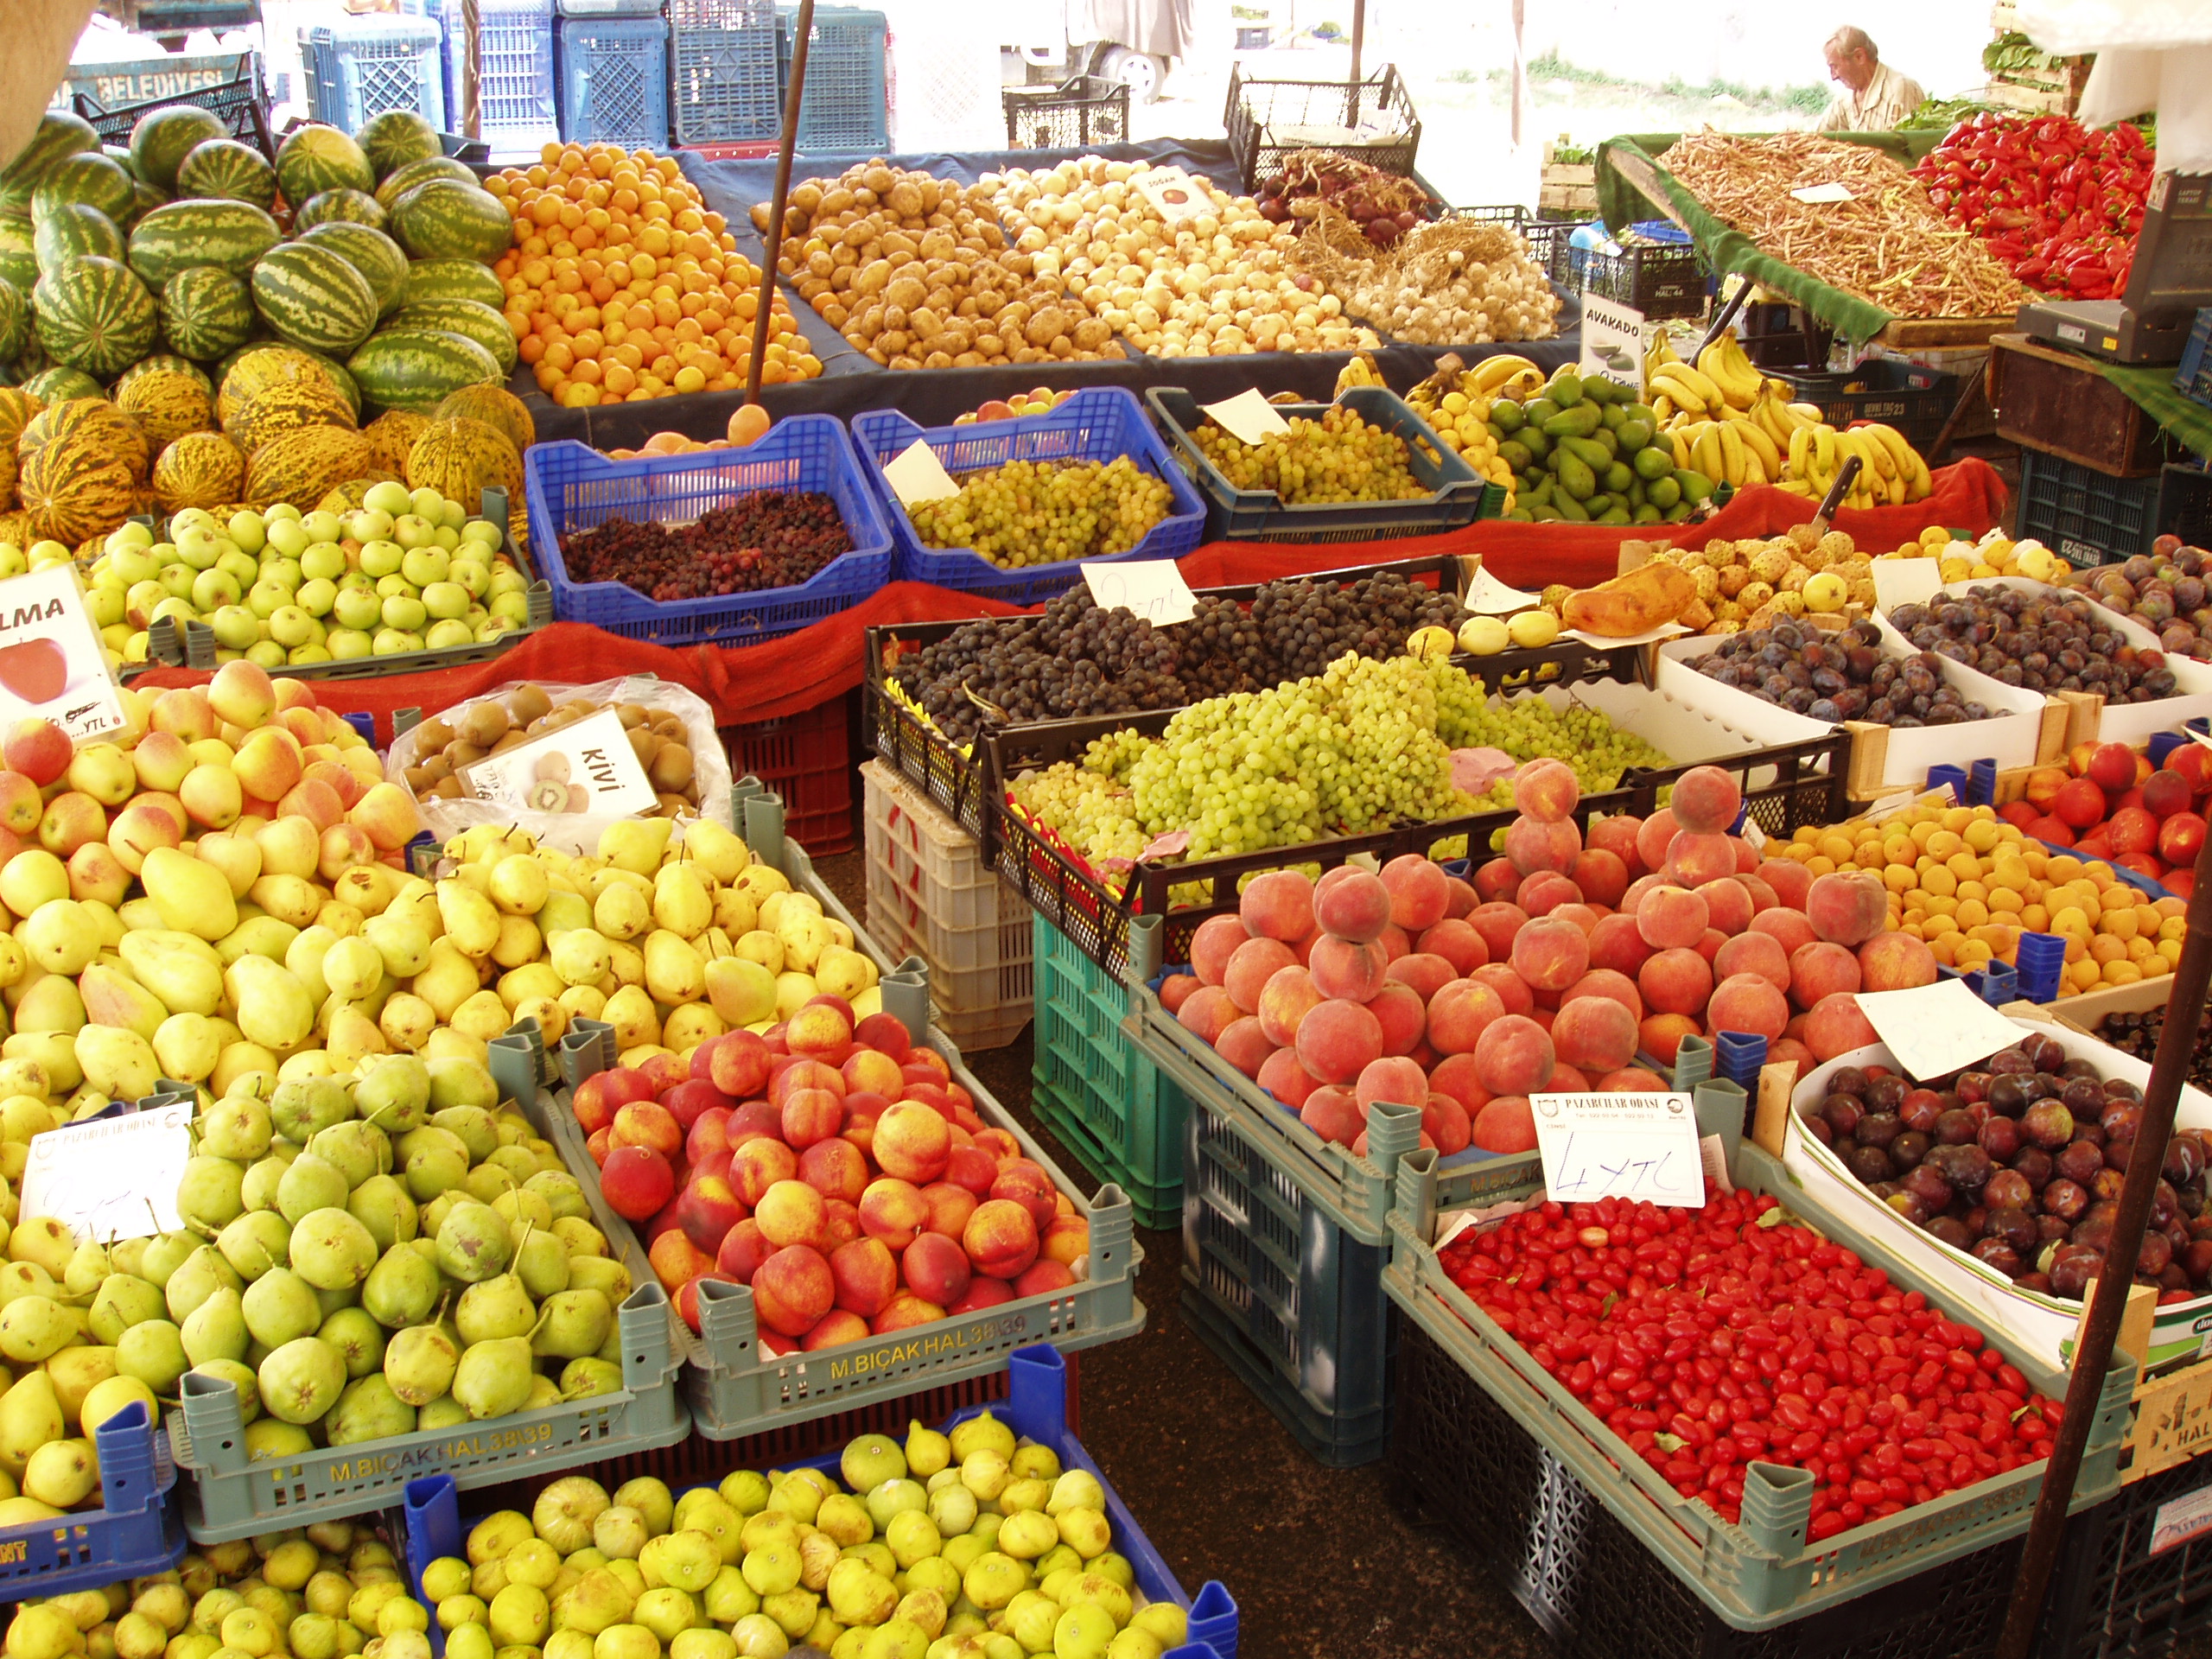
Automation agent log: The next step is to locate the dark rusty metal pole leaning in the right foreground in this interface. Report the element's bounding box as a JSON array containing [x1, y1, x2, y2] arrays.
[[1998, 842, 2212, 1659]]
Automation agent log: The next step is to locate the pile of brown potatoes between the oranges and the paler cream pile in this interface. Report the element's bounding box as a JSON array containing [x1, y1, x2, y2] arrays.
[[752, 162, 1115, 370]]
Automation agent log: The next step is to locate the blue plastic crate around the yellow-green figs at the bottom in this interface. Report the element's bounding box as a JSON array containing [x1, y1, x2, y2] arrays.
[[400, 1344, 1236, 1659]]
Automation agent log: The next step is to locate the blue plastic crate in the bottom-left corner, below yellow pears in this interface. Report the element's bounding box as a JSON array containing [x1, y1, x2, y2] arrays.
[[0, 1405, 186, 1601]]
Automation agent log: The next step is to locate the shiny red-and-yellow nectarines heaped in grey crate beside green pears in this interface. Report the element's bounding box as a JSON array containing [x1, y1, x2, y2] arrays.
[[573, 995, 1090, 1354]]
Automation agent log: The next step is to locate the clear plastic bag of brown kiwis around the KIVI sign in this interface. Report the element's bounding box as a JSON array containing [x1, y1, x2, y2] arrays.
[[385, 679, 734, 854]]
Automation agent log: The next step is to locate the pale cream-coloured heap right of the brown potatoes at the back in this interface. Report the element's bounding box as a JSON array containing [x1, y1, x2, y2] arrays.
[[982, 155, 1378, 356]]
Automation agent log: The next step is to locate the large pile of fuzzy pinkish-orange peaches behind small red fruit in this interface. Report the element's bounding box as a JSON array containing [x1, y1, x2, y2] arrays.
[[1161, 761, 1936, 1157]]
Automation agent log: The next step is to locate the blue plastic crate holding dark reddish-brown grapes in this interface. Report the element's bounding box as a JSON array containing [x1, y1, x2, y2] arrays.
[[522, 416, 892, 646]]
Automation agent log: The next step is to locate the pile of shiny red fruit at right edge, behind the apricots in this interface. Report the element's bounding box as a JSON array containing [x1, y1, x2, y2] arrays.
[[1998, 743, 2212, 898]]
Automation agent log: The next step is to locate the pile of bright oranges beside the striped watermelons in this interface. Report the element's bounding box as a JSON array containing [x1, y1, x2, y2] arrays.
[[485, 143, 823, 410]]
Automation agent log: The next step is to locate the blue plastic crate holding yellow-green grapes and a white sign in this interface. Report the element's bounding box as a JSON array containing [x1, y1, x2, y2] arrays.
[[852, 387, 1205, 604]]
